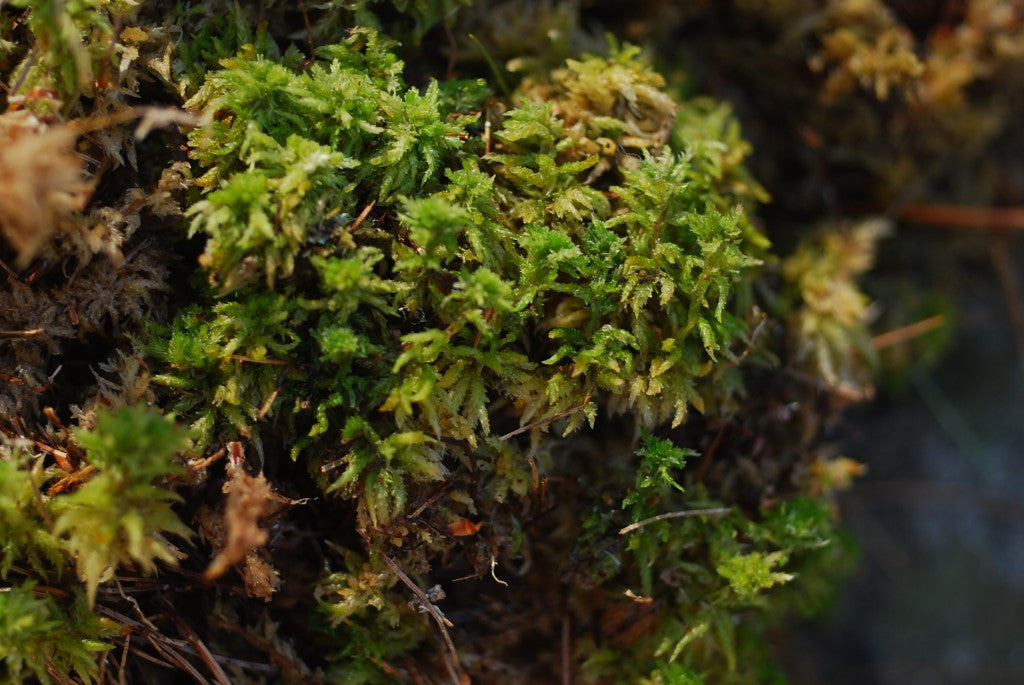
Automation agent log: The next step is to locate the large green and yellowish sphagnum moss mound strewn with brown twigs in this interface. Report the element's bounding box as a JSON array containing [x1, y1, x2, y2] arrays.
[[0, 2, 871, 683]]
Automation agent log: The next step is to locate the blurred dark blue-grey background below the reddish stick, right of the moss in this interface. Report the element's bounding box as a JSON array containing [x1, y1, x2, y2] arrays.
[[778, 226, 1024, 685]]
